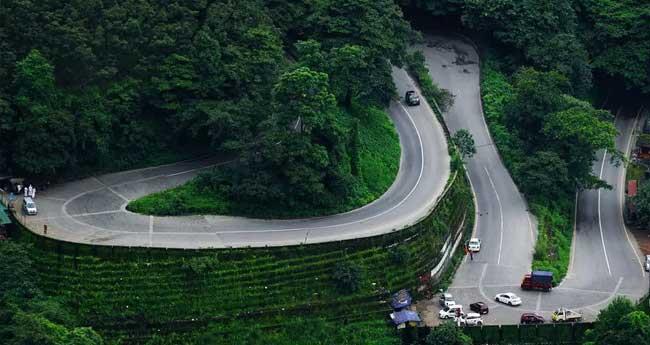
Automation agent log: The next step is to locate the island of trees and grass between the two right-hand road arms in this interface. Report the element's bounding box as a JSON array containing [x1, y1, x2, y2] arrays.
[[481, 57, 620, 283]]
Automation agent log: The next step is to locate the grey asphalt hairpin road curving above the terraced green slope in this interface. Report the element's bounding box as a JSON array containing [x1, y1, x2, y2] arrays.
[[21, 69, 450, 248]]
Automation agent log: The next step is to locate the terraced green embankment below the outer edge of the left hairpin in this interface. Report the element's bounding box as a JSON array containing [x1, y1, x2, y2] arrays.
[[16, 174, 474, 343]]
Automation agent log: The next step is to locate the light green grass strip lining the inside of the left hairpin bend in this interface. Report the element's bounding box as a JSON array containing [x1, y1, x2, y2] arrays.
[[128, 108, 400, 218]]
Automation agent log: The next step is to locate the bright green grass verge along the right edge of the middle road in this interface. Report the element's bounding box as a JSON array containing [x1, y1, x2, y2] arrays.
[[481, 56, 574, 283]]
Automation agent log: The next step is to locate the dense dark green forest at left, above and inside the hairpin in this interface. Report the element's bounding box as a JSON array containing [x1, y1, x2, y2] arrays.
[[0, 0, 412, 214]]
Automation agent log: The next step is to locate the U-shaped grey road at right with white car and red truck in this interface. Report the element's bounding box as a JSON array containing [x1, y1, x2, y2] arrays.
[[419, 36, 648, 324]]
